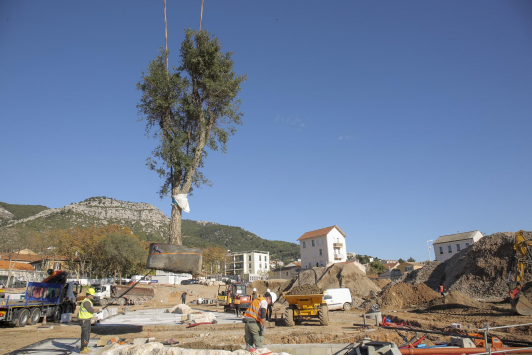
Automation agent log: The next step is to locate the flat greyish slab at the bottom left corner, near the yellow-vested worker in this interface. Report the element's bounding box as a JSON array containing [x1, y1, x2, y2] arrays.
[[5, 338, 101, 355]]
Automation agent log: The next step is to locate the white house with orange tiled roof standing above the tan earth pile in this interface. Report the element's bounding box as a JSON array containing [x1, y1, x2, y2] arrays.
[[298, 225, 347, 269]]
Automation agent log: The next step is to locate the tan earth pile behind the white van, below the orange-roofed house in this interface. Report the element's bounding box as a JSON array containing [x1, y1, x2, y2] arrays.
[[275, 263, 381, 302]]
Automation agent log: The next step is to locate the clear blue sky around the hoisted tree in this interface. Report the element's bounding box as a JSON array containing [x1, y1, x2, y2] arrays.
[[0, 0, 532, 260]]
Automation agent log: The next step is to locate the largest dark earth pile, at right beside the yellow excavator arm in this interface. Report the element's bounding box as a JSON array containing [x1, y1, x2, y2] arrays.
[[398, 232, 532, 299]]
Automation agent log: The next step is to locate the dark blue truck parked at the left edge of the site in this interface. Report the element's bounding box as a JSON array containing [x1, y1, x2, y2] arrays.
[[0, 270, 79, 327]]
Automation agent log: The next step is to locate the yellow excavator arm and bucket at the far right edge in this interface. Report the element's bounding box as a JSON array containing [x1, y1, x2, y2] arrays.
[[508, 230, 532, 316]]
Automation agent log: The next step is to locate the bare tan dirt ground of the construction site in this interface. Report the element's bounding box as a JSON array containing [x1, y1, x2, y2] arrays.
[[0, 285, 532, 354]]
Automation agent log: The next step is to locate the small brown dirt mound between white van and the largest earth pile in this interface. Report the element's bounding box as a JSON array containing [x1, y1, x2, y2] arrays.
[[377, 282, 441, 309]]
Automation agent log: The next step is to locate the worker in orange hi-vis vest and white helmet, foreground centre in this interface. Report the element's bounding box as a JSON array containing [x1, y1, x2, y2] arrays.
[[243, 293, 272, 352]]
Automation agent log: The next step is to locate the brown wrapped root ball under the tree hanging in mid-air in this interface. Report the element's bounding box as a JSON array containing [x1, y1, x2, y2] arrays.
[[146, 243, 203, 275]]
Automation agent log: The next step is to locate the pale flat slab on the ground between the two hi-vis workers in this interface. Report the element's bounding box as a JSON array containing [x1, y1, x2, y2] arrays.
[[98, 308, 242, 326]]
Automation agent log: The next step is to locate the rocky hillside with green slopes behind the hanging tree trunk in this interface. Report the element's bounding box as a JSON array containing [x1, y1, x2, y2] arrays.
[[0, 197, 299, 261]]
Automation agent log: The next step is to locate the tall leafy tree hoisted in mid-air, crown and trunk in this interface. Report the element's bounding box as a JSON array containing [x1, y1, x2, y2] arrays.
[[137, 29, 246, 245]]
